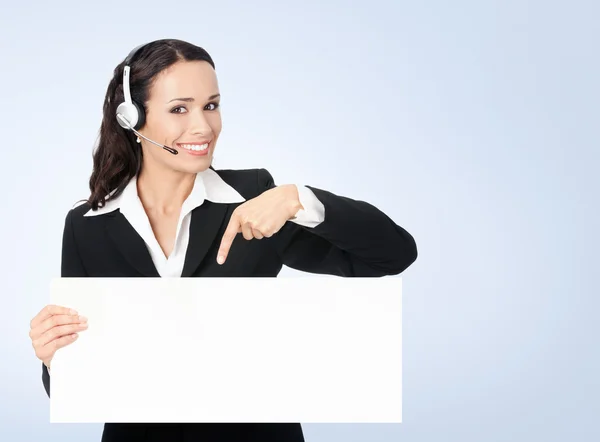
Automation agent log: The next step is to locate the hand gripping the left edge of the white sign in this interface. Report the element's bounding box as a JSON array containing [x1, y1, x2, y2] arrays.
[[29, 305, 87, 368]]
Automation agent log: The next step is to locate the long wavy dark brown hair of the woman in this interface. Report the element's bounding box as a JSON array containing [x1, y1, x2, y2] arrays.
[[88, 39, 215, 210]]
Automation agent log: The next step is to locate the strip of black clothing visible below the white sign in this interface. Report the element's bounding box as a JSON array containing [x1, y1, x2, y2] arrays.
[[102, 423, 305, 442]]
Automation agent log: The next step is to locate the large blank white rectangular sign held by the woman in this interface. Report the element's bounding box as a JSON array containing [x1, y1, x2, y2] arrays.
[[50, 277, 402, 423]]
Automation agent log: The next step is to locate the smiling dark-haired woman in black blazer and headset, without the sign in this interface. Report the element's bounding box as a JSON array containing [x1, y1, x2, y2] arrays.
[[30, 39, 417, 442]]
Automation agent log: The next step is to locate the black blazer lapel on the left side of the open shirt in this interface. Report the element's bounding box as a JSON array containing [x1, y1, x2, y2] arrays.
[[106, 211, 160, 277]]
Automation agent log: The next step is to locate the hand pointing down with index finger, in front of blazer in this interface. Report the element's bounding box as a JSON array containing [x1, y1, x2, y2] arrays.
[[217, 184, 303, 264]]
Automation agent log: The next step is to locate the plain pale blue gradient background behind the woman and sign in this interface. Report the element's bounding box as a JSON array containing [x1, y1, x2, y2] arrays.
[[0, 0, 600, 442]]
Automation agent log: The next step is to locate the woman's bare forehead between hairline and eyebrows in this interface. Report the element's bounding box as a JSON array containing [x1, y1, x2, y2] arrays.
[[149, 61, 219, 102]]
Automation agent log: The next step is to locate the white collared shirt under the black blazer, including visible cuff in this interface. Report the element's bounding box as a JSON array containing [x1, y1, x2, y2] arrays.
[[84, 169, 325, 277]]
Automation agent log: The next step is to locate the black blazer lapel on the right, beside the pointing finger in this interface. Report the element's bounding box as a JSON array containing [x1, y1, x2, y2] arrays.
[[181, 200, 229, 277]]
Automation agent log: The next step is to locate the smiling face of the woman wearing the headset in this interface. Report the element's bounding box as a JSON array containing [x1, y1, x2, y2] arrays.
[[139, 61, 221, 173]]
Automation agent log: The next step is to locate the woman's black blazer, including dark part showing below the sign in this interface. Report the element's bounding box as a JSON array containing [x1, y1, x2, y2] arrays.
[[42, 169, 417, 442]]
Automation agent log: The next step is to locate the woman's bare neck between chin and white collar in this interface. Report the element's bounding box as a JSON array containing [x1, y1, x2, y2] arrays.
[[137, 162, 196, 215]]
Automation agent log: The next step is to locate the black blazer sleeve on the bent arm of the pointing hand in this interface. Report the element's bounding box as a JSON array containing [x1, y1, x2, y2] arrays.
[[258, 169, 417, 277]]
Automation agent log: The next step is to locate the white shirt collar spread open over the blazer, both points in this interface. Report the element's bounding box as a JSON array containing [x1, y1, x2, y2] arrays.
[[84, 168, 246, 216]]
